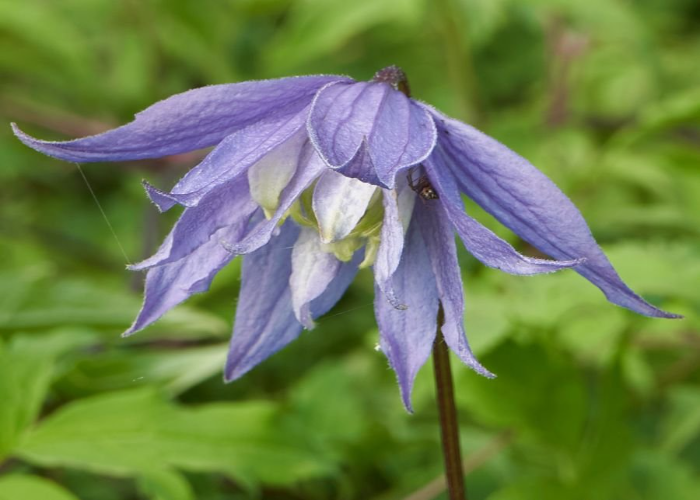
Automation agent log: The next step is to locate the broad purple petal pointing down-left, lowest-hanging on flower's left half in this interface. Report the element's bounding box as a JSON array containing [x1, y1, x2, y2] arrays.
[[225, 220, 302, 382]]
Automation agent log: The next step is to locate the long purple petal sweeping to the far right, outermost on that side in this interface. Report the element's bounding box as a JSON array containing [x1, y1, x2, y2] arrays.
[[432, 104, 680, 318]]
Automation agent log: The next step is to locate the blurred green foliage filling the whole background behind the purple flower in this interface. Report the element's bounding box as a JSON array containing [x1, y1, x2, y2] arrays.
[[0, 0, 700, 500]]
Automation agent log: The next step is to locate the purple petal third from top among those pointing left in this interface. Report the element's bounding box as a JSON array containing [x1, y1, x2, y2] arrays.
[[129, 177, 257, 271]]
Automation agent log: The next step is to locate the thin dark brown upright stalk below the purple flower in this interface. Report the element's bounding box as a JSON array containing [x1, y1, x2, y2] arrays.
[[433, 306, 467, 500]]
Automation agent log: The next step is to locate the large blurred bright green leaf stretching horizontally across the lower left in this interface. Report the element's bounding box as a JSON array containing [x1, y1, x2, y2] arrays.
[[18, 388, 331, 484]]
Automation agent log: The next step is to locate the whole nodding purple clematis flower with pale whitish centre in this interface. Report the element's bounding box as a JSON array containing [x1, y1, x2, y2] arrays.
[[14, 67, 675, 410]]
